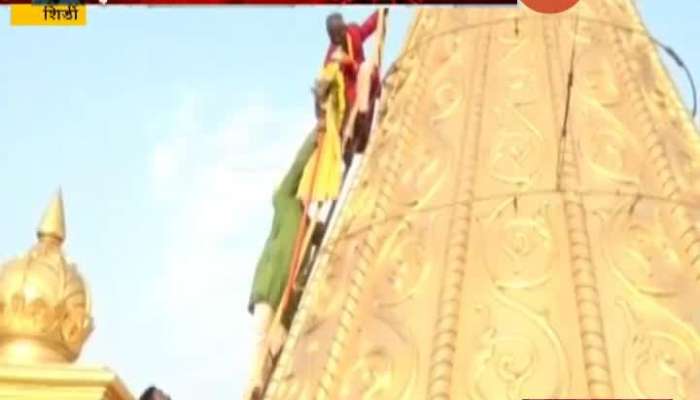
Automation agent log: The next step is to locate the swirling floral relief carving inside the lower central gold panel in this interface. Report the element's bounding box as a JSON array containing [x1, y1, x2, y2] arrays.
[[471, 200, 571, 400]]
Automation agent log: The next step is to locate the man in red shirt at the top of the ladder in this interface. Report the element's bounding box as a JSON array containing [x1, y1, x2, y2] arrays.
[[324, 8, 388, 159]]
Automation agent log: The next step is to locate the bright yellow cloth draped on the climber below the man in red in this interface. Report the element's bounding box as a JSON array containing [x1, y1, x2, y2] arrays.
[[297, 62, 346, 202]]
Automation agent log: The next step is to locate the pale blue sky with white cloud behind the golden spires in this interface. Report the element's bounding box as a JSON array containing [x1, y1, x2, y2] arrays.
[[0, 0, 700, 399]]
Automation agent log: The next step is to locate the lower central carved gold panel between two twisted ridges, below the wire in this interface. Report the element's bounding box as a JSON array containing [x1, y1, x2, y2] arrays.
[[451, 195, 586, 400]]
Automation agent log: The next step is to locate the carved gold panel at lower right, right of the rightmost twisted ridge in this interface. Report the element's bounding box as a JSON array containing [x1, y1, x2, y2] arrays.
[[589, 197, 700, 400]]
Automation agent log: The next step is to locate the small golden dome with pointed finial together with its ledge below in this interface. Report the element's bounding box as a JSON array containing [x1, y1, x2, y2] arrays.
[[0, 189, 134, 400]]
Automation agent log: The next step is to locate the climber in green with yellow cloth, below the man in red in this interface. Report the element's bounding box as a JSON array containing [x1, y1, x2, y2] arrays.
[[246, 63, 345, 399]]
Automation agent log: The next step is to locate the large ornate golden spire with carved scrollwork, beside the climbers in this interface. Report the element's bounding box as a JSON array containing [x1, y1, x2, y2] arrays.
[[266, 0, 700, 400]]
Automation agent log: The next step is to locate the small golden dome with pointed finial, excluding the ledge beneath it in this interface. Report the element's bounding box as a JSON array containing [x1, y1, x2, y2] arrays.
[[0, 191, 93, 362]]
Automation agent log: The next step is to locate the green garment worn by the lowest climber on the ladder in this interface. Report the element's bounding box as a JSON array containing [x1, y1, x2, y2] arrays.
[[248, 132, 316, 313]]
